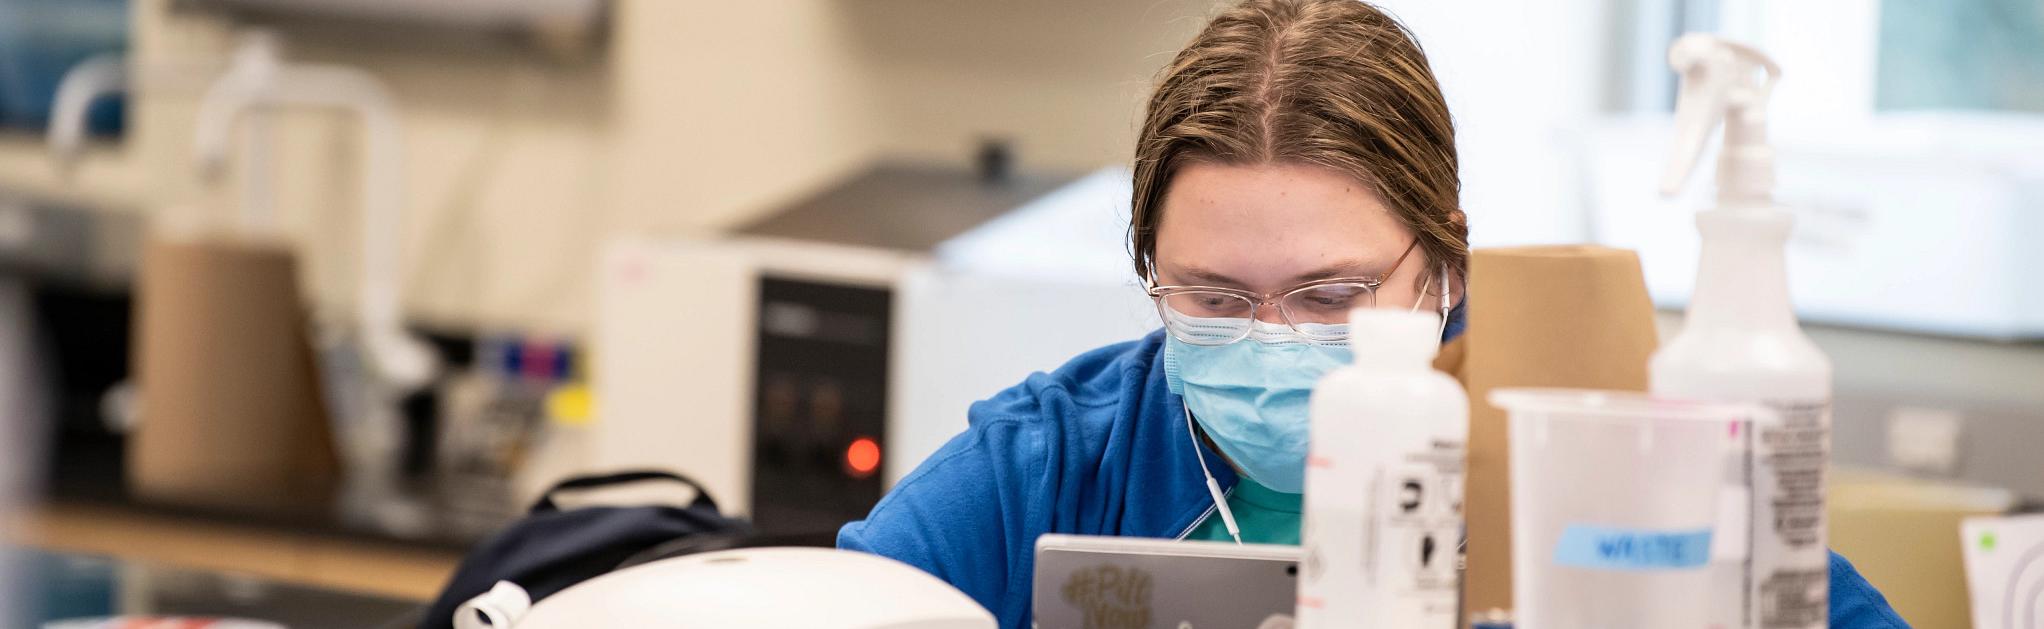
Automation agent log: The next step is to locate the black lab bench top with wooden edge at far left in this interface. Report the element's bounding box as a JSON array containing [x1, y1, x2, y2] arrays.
[[24, 420, 517, 600]]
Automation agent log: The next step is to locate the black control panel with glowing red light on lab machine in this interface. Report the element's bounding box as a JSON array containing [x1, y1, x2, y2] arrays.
[[752, 278, 891, 535]]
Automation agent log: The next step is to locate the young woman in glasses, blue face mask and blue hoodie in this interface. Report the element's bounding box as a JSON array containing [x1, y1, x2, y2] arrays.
[[838, 0, 1905, 629]]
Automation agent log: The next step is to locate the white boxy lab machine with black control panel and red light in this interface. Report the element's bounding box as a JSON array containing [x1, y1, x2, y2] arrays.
[[587, 163, 1157, 535]]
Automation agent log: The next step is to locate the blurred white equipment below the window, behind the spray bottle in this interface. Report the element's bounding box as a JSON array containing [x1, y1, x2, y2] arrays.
[[1586, 112, 2044, 339]]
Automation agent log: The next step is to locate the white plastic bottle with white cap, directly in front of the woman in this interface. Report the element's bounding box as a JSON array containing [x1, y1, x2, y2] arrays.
[[1296, 308, 1470, 629]]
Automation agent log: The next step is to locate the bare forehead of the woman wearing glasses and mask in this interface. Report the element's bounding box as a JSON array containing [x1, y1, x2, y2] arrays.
[[1157, 161, 1410, 288]]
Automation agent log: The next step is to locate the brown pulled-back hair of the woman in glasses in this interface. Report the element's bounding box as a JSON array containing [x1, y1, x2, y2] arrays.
[[1128, 0, 1470, 290]]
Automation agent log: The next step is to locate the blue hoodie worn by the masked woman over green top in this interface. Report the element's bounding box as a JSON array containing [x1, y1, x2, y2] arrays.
[[838, 328, 1907, 629]]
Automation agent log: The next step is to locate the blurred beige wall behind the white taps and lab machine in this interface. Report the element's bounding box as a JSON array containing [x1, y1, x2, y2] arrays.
[[0, 0, 1212, 333]]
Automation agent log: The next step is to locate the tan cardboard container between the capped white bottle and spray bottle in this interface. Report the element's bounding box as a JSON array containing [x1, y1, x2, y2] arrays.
[[1435, 247, 1658, 613]]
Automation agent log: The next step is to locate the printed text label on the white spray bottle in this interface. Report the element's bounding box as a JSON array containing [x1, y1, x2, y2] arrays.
[[1748, 400, 1831, 629]]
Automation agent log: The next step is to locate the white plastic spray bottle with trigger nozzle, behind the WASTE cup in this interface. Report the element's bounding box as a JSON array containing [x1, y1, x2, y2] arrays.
[[1650, 35, 1831, 629]]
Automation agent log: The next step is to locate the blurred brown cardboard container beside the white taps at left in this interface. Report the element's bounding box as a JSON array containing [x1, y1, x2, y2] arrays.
[[127, 239, 339, 513]]
